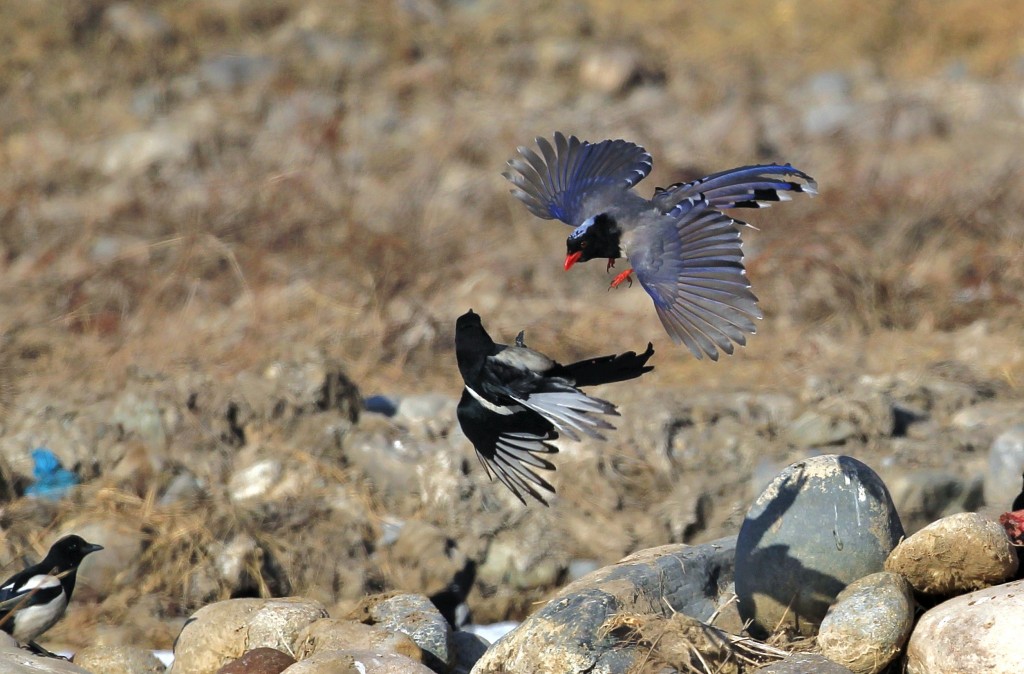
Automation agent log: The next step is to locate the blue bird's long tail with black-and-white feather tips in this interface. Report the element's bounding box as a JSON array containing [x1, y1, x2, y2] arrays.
[[651, 164, 818, 213]]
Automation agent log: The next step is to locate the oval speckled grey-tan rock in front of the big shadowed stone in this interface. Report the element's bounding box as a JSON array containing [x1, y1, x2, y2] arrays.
[[817, 572, 914, 674]]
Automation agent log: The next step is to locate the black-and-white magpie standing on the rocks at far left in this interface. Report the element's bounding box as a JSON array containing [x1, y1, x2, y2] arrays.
[[0, 534, 103, 654]]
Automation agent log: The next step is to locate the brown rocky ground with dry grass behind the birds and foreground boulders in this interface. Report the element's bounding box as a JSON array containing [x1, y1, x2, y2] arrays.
[[0, 0, 1024, 659]]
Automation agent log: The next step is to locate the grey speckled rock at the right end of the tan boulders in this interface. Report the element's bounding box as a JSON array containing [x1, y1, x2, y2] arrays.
[[350, 594, 455, 672]]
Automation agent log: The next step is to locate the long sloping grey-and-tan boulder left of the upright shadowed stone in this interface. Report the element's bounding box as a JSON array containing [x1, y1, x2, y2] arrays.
[[473, 537, 735, 674]]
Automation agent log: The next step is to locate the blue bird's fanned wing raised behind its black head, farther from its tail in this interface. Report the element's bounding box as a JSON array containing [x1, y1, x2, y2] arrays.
[[502, 132, 651, 226]]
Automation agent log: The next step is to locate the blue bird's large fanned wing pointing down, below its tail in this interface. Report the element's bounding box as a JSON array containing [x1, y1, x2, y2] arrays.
[[630, 198, 761, 361]]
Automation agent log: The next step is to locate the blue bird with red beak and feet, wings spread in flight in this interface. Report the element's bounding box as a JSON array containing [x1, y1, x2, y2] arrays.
[[503, 133, 817, 361]]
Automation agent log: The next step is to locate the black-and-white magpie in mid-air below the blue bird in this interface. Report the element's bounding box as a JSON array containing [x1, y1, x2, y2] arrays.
[[455, 309, 654, 505]]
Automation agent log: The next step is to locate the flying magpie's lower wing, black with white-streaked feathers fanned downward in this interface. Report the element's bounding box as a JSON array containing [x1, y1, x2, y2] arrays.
[[457, 389, 558, 505]]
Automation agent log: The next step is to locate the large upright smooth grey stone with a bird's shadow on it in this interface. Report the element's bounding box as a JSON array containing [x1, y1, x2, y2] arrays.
[[735, 455, 903, 637]]
